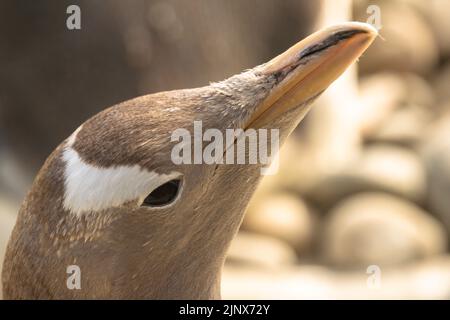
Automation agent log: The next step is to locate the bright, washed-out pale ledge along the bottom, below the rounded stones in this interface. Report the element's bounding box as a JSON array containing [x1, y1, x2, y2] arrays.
[[222, 255, 450, 300]]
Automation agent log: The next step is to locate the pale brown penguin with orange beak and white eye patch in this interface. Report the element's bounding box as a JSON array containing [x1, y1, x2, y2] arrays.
[[2, 22, 377, 299]]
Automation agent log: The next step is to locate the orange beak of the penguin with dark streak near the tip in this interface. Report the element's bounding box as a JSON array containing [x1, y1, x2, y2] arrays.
[[246, 22, 378, 128]]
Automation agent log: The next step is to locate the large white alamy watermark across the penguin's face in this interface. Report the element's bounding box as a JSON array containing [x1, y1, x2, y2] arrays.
[[170, 121, 280, 175]]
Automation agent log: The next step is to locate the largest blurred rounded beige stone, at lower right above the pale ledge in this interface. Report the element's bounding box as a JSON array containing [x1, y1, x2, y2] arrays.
[[321, 193, 447, 267]]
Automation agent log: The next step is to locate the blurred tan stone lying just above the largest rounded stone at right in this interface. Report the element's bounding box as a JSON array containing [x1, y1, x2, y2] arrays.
[[308, 145, 426, 208]]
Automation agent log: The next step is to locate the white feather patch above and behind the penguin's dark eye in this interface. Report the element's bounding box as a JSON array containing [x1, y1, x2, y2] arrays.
[[63, 134, 181, 216]]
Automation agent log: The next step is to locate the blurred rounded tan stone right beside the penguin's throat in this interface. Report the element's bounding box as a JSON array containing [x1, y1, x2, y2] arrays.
[[242, 193, 315, 254]]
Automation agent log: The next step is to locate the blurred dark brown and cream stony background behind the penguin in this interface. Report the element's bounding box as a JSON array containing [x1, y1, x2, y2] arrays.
[[0, 0, 450, 299]]
